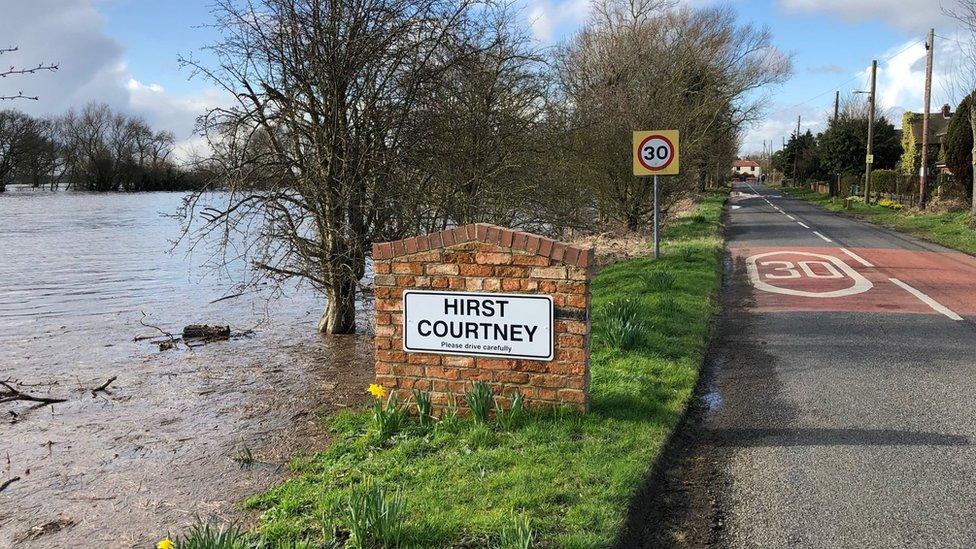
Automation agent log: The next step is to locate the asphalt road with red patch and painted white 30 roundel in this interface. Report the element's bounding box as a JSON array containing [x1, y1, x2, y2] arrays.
[[624, 184, 976, 548]]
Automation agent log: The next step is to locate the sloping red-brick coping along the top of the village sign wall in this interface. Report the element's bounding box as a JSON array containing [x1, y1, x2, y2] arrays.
[[373, 223, 594, 267]]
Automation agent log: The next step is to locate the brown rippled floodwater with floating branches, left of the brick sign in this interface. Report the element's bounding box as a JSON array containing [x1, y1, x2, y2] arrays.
[[0, 188, 371, 547]]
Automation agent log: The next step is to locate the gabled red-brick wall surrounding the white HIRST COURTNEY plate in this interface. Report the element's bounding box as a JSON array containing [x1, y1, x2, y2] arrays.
[[373, 223, 594, 410]]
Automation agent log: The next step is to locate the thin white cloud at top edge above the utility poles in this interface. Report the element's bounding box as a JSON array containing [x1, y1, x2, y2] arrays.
[[779, 0, 955, 30]]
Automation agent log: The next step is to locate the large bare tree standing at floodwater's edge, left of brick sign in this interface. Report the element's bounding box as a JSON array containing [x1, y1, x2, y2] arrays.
[[183, 0, 508, 333]]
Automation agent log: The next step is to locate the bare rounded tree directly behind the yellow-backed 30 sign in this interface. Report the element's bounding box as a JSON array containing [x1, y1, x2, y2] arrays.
[[558, 0, 791, 230]]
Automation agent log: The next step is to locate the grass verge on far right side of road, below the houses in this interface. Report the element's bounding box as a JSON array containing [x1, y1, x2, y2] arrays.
[[781, 187, 976, 254]]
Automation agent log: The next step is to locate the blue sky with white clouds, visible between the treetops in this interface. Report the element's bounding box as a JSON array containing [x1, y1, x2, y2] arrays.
[[0, 0, 962, 157]]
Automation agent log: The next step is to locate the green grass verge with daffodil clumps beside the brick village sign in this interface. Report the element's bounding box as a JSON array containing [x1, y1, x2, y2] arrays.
[[187, 195, 724, 547]]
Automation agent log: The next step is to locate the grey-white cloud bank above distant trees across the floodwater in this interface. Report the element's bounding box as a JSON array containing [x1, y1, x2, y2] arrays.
[[0, 0, 221, 162]]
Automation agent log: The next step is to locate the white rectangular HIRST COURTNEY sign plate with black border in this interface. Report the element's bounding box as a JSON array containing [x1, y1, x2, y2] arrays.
[[403, 290, 554, 360]]
